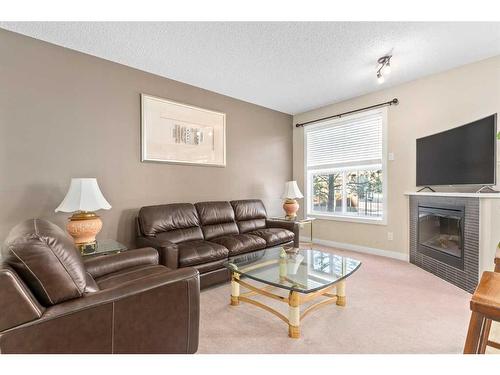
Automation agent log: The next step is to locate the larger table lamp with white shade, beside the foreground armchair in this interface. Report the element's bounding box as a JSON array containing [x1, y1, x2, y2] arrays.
[[55, 178, 111, 253]]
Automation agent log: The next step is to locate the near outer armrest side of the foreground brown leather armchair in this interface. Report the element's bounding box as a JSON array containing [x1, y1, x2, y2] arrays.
[[0, 268, 200, 354]]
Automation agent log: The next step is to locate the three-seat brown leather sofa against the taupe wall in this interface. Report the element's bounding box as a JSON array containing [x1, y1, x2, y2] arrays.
[[136, 199, 299, 288]]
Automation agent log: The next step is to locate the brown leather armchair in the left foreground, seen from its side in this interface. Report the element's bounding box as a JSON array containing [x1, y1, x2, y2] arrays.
[[0, 219, 199, 353]]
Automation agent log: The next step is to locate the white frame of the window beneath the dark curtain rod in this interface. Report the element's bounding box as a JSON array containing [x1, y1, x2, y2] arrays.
[[303, 107, 389, 225]]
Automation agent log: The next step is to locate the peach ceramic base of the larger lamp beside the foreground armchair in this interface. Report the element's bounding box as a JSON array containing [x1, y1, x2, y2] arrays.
[[66, 212, 102, 253]]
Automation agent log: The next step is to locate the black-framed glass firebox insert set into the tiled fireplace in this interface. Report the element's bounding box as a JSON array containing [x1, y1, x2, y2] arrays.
[[417, 204, 465, 270]]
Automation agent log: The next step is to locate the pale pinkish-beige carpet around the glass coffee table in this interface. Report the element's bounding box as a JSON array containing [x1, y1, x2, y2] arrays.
[[198, 246, 480, 353]]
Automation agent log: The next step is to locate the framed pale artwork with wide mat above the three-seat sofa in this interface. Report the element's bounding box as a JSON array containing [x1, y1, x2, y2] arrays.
[[141, 94, 226, 167]]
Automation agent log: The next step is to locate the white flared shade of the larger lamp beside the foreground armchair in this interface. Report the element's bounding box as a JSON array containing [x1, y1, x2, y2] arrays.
[[55, 178, 111, 212]]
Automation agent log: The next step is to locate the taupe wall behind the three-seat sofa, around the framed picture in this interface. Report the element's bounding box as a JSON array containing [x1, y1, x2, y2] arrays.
[[0, 29, 292, 245]]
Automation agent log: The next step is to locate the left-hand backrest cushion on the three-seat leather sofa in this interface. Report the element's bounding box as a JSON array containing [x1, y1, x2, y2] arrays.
[[139, 203, 203, 243]]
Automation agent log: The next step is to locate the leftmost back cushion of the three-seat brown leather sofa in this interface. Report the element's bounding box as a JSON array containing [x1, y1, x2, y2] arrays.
[[139, 203, 201, 239]]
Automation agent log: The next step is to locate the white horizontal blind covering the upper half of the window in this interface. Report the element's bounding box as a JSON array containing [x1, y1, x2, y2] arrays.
[[306, 111, 382, 169]]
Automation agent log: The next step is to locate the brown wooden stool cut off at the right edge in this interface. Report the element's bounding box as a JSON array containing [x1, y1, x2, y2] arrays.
[[464, 272, 500, 354]]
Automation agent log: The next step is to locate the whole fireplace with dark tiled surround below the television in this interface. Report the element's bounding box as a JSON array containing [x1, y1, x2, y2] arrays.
[[409, 193, 480, 293]]
